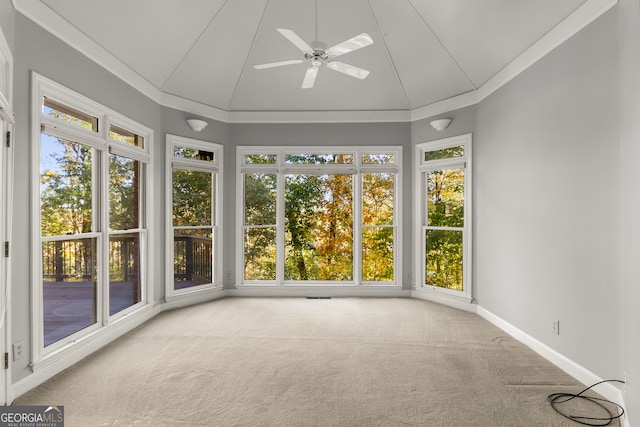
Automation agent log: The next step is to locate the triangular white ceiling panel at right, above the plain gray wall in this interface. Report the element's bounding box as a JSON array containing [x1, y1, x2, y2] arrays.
[[410, 0, 586, 87]]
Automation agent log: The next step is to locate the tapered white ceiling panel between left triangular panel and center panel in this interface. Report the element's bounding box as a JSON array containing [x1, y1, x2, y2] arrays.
[[162, 0, 267, 110]]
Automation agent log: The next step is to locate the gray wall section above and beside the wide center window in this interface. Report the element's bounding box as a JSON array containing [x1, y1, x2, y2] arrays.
[[230, 123, 413, 289]]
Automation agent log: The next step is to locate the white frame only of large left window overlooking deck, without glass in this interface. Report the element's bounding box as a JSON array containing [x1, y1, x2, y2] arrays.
[[31, 72, 154, 371]]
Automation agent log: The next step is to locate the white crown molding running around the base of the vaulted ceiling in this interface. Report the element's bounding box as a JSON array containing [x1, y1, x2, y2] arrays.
[[12, 0, 618, 123]]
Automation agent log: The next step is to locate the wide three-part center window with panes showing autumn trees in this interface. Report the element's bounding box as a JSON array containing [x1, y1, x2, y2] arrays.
[[237, 147, 401, 285]]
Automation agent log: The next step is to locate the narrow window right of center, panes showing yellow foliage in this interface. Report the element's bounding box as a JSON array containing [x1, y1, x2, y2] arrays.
[[416, 135, 471, 298]]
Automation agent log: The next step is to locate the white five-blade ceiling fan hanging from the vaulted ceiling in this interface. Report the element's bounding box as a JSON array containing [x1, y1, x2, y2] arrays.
[[253, 28, 373, 89]]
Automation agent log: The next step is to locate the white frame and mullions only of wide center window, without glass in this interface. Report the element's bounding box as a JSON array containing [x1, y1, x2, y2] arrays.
[[235, 145, 403, 289]]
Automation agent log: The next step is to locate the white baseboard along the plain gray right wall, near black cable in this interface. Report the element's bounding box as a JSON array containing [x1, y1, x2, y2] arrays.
[[477, 306, 629, 427]]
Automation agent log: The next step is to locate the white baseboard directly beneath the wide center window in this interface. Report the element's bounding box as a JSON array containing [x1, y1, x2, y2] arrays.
[[225, 285, 411, 298]]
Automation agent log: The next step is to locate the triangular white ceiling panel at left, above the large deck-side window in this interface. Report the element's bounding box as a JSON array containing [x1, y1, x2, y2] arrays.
[[42, 0, 225, 88]]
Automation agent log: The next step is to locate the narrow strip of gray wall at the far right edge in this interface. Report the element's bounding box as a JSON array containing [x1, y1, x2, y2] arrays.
[[618, 0, 640, 425]]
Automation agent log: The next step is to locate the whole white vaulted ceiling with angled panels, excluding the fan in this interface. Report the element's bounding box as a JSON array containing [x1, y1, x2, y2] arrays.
[[14, 0, 615, 121]]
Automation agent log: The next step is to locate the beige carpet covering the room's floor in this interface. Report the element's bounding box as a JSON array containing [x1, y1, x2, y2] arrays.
[[14, 298, 618, 427]]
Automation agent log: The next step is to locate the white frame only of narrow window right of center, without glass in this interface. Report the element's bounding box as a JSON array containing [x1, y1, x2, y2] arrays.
[[413, 133, 473, 302]]
